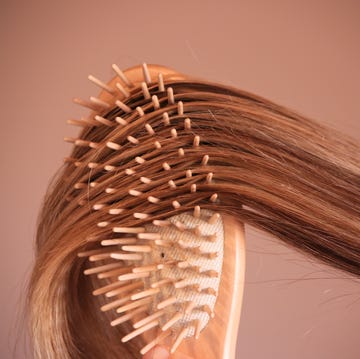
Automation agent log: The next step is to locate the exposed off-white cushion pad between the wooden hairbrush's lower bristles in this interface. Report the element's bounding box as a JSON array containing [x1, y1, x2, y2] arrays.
[[144, 210, 224, 337]]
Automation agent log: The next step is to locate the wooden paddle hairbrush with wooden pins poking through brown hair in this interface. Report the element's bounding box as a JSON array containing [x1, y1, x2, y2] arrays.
[[65, 64, 245, 359]]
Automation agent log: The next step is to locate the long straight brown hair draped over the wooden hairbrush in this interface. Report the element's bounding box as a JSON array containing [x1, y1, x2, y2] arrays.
[[29, 74, 360, 358]]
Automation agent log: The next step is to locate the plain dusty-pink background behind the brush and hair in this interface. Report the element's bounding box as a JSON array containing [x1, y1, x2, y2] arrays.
[[0, 0, 360, 359]]
